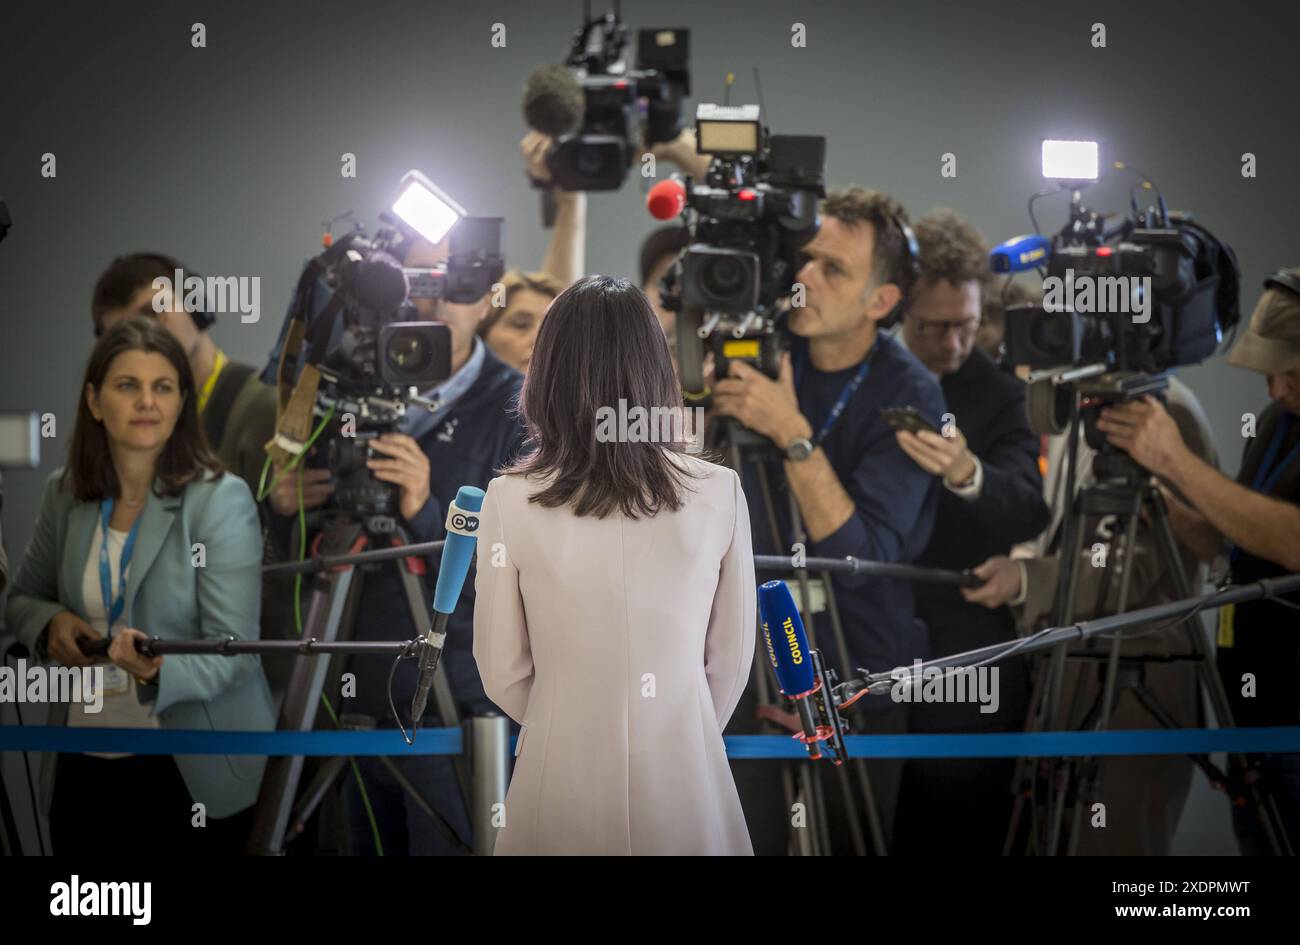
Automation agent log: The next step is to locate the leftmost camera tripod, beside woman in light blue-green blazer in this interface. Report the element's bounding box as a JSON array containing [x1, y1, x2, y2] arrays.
[[248, 511, 471, 855]]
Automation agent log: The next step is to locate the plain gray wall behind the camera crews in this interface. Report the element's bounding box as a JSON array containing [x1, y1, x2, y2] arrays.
[[0, 0, 1300, 850]]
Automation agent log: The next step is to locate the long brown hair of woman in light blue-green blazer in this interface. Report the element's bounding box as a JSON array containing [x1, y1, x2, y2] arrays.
[[62, 316, 225, 502]]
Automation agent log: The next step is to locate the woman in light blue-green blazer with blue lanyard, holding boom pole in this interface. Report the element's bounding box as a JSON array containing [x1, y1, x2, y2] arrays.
[[5, 318, 274, 855]]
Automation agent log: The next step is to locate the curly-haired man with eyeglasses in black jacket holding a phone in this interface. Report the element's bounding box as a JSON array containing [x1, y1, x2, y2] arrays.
[[896, 209, 1049, 855]]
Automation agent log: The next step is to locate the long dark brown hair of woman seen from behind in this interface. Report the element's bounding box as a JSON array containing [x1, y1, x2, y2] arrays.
[[503, 276, 707, 519]]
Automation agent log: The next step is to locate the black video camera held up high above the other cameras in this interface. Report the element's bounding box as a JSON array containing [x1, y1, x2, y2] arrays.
[[546, 13, 690, 191]]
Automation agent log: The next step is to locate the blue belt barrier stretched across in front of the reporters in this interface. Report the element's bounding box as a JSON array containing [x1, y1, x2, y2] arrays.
[[0, 725, 1300, 759]]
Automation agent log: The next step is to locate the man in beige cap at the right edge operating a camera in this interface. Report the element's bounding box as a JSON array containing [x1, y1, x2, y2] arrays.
[[1097, 268, 1300, 855]]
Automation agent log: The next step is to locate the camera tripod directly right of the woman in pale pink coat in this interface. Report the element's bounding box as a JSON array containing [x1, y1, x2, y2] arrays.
[[712, 420, 887, 857]]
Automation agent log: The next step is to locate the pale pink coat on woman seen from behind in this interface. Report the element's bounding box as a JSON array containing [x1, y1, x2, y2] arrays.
[[475, 456, 757, 855]]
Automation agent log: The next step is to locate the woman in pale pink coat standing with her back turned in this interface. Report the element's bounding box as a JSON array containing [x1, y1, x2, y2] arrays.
[[475, 276, 757, 854]]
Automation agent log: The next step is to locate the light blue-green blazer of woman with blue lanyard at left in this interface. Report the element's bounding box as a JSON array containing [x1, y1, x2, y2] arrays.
[[5, 469, 276, 818]]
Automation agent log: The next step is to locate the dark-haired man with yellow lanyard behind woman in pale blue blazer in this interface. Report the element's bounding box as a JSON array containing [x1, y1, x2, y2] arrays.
[[91, 252, 276, 497]]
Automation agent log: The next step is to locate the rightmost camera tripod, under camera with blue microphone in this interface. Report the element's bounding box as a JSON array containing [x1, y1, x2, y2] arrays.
[[1004, 402, 1291, 855]]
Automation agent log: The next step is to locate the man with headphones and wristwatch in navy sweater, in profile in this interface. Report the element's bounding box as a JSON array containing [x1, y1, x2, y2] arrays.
[[712, 187, 946, 854]]
